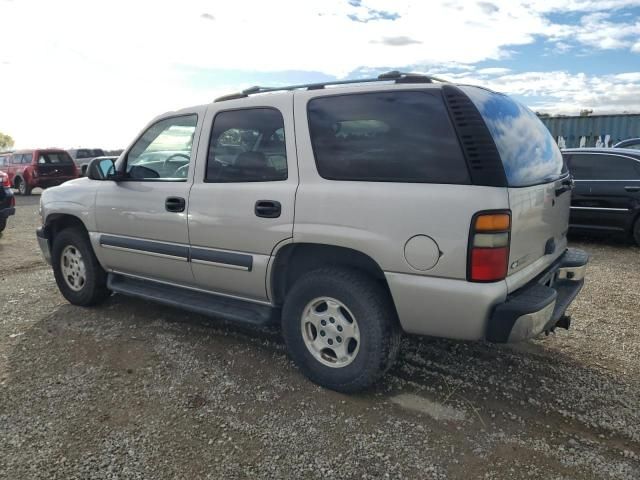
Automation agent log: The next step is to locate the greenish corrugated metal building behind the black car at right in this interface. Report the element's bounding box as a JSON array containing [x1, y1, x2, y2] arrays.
[[540, 113, 640, 148]]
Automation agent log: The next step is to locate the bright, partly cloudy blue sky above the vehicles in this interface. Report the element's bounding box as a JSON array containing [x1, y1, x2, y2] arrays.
[[0, 0, 640, 148]]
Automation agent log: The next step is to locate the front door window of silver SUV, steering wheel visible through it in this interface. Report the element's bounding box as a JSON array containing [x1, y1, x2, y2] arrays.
[[125, 115, 198, 182]]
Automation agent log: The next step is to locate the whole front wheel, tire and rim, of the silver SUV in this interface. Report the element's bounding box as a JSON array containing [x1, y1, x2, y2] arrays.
[[51, 228, 109, 306]]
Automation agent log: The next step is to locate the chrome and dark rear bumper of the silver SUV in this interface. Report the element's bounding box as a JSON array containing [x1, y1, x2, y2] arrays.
[[486, 248, 589, 343]]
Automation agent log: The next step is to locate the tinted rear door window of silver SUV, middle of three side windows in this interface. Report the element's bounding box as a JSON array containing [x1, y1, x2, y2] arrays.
[[205, 108, 287, 182]]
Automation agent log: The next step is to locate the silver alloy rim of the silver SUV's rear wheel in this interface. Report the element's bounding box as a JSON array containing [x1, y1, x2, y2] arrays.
[[301, 297, 360, 368]]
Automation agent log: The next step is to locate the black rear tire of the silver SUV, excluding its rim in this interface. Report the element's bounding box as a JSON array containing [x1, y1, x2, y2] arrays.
[[282, 268, 400, 393]]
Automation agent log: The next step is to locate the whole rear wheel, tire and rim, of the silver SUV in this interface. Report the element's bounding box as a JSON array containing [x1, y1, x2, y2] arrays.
[[282, 268, 400, 392]]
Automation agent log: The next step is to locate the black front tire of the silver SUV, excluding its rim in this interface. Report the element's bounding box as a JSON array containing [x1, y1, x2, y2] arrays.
[[51, 228, 110, 307]]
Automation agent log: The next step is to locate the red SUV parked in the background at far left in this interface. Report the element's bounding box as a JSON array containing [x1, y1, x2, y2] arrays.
[[0, 148, 78, 195]]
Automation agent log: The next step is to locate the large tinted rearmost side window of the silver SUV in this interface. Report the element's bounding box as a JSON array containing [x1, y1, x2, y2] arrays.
[[308, 91, 470, 184]]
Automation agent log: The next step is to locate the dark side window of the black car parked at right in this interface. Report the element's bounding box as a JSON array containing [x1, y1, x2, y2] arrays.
[[569, 155, 640, 180]]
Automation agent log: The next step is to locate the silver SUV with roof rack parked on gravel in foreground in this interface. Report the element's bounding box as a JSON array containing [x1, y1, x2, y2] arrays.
[[37, 72, 588, 392]]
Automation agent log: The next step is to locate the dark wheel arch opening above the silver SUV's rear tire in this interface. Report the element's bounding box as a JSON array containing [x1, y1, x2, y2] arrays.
[[269, 243, 395, 308]]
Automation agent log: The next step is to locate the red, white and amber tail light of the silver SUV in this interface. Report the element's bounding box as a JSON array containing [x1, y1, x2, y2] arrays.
[[467, 210, 511, 282]]
